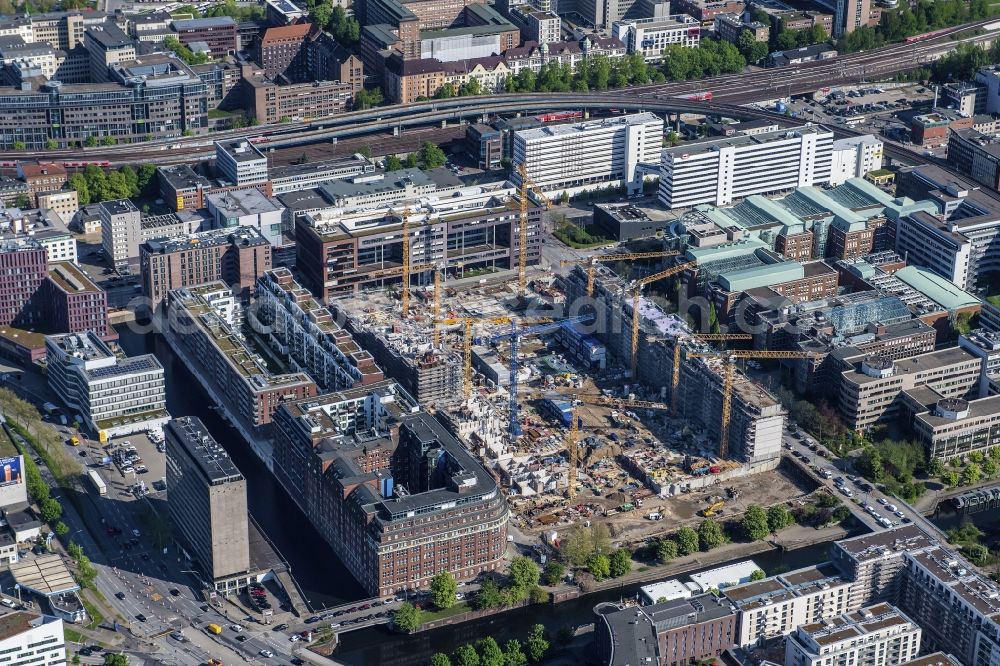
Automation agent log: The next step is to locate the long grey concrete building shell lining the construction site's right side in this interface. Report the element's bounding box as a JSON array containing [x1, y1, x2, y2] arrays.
[[566, 265, 785, 463]]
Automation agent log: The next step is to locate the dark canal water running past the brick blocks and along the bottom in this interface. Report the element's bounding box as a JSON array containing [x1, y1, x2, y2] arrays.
[[118, 326, 844, 666]]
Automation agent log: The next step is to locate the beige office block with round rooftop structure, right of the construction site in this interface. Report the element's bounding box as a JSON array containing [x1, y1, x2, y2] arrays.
[[838, 347, 982, 432]]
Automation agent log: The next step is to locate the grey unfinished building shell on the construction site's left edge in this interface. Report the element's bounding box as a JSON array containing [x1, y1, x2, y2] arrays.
[[331, 301, 463, 405]]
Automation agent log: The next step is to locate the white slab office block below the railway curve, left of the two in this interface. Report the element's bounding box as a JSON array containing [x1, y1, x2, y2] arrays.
[[512, 112, 663, 195]]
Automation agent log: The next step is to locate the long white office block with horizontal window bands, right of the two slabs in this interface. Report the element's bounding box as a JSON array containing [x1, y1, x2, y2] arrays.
[[659, 126, 833, 208]]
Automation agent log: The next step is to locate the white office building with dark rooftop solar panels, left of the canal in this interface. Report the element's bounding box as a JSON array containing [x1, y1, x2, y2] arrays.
[[45, 333, 169, 435]]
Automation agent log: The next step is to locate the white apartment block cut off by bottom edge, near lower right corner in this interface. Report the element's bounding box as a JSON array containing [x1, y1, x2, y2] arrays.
[[785, 603, 920, 666]]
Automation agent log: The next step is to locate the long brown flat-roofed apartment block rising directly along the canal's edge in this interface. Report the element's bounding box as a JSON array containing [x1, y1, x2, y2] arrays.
[[164, 282, 317, 436]]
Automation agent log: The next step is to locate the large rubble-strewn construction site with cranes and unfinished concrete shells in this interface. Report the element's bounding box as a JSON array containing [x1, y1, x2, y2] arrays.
[[320, 208, 809, 540]]
